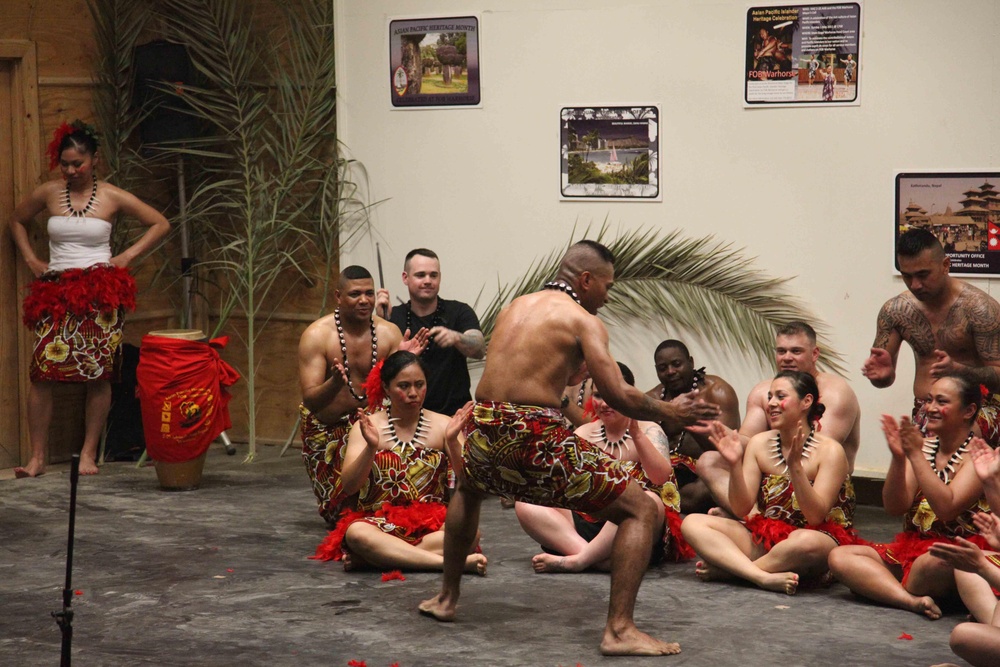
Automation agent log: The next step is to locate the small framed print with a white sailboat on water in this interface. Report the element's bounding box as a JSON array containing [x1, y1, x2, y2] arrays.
[[560, 106, 660, 200]]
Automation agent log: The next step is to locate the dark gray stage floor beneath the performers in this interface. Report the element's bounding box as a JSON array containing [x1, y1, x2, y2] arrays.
[[0, 447, 964, 667]]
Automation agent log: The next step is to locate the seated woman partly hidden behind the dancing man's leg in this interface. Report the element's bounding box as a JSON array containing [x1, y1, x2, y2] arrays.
[[514, 363, 688, 573]]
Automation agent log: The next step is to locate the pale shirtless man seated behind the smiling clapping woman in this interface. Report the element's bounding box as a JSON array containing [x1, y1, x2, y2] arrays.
[[698, 321, 861, 513]]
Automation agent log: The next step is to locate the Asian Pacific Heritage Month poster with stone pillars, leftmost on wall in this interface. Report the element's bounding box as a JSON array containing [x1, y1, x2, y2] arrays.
[[389, 16, 480, 109]]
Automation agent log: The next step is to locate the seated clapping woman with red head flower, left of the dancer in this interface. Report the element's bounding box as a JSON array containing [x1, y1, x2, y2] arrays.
[[313, 351, 486, 575]]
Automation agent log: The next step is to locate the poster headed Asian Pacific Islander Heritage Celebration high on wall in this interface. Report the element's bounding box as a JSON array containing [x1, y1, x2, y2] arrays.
[[743, 2, 861, 107]]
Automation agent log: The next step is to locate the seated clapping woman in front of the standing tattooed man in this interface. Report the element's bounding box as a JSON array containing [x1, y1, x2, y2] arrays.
[[830, 373, 988, 619]]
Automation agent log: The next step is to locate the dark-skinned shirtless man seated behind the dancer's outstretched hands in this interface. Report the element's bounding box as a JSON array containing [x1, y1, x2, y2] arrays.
[[646, 340, 740, 514]]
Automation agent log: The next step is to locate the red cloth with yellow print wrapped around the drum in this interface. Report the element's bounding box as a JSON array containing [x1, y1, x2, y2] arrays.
[[136, 336, 240, 463]]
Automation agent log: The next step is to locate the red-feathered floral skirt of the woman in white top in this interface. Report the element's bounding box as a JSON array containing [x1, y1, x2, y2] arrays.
[[23, 264, 135, 382]]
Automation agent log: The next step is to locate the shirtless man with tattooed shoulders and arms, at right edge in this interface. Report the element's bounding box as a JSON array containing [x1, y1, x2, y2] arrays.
[[861, 229, 1000, 447]]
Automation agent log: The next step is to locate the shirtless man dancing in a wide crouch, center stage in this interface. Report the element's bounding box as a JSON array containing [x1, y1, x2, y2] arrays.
[[420, 241, 719, 655]]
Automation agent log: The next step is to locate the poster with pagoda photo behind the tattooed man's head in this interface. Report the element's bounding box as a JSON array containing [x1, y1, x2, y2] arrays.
[[893, 172, 1000, 276]]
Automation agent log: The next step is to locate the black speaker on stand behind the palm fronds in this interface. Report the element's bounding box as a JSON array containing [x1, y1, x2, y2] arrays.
[[132, 39, 200, 144]]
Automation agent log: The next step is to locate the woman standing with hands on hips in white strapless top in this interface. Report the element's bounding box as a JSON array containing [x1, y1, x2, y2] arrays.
[[10, 120, 170, 477]]
